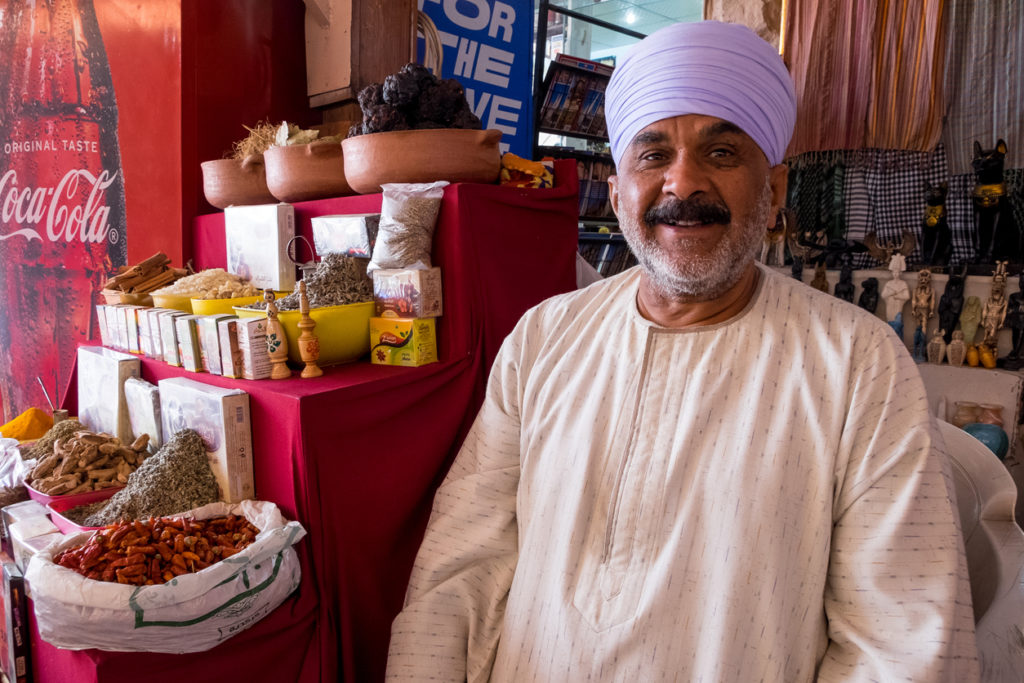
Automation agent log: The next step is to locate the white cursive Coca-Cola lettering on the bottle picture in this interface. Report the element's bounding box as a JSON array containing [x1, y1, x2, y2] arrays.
[[0, 169, 118, 243]]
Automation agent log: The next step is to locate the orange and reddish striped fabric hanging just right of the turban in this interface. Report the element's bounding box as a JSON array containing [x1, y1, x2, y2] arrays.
[[782, 0, 945, 156]]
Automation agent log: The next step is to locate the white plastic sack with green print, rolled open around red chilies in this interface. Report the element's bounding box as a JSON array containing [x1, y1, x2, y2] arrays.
[[26, 501, 306, 653]]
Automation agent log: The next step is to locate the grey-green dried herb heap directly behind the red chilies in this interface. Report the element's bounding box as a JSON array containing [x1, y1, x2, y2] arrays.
[[72, 429, 220, 526]]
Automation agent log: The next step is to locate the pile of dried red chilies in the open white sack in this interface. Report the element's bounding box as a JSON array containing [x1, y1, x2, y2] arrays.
[[54, 515, 259, 586]]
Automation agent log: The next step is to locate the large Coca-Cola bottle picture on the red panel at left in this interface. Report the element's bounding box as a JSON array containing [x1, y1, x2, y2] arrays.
[[0, 0, 125, 419]]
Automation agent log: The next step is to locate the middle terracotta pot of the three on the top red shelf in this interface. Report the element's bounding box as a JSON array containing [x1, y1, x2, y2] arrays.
[[263, 140, 354, 202]]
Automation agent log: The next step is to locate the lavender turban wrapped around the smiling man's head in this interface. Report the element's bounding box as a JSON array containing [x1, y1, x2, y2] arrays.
[[604, 22, 797, 166]]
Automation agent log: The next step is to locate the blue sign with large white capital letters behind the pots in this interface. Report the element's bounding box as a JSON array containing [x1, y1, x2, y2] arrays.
[[418, 0, 534, 159]]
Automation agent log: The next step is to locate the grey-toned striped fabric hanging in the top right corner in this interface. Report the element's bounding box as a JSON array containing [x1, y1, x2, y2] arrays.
[[942, 0, 1024, 176]]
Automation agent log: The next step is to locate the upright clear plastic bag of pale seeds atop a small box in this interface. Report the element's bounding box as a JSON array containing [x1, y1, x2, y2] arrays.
[[367, 180, 449, 273]]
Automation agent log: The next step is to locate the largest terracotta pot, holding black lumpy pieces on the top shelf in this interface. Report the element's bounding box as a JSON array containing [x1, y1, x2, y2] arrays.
[[341, 128, 502, 195]]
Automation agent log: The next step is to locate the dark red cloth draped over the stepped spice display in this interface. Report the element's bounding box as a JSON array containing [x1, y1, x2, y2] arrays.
[[36, 162, 577, 683]]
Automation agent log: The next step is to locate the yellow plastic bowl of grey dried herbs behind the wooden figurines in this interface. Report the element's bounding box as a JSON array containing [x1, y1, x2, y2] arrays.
[[234, 301, 374, 366]]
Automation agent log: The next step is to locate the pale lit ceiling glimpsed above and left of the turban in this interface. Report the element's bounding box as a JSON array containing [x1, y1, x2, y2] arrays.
[[551, 0, 703, 52]]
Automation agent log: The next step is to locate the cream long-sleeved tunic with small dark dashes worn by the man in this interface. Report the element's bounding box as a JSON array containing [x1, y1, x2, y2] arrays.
[[388, 268, 977, 683]]
